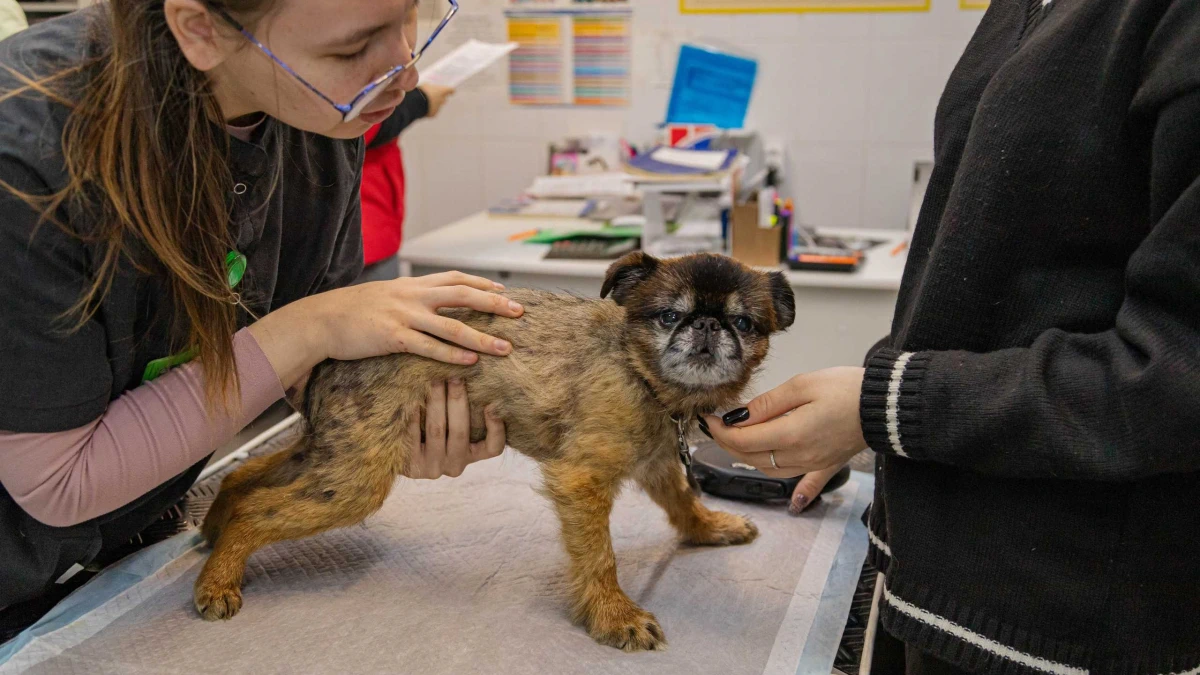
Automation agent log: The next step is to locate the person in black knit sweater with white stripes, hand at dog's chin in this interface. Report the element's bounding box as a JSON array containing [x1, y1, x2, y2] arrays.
[[707, 0, 1200, 675]]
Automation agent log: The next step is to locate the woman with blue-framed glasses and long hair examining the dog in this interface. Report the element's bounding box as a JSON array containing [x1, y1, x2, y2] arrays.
[[0, 0, 504, 615]]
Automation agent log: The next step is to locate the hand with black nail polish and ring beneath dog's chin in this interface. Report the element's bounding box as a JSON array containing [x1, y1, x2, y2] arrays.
[[704, 368, 866, 513]]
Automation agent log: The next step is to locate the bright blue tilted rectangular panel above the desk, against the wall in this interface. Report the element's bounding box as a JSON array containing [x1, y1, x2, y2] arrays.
[[666, 44, 758, 129]]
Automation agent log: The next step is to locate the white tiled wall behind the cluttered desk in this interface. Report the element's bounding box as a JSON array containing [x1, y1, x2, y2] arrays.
[[403, 0, 982, 237]]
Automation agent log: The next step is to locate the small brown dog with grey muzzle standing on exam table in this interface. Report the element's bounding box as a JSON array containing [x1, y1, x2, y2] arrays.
[[196, 253, 796, 651]]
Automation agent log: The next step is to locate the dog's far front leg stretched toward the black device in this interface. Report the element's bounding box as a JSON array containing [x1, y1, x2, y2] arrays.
[[637, 452, 758, 546]]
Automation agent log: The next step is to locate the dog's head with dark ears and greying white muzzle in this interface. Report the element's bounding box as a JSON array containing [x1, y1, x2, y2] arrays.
[[600, 252, 796, 392]]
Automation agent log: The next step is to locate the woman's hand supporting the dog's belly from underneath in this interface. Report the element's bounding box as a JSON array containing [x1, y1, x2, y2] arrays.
[[404, 380, 504, 479]]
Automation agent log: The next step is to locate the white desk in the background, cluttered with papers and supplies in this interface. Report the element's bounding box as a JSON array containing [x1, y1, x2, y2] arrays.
[[400, 213, 906, 392]]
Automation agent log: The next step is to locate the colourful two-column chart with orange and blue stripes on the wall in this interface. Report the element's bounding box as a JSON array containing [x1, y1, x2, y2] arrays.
[[505, 0, 631, 107]]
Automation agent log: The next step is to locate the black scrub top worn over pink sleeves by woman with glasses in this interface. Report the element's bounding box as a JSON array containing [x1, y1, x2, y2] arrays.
[[0, 5, 364, 607]]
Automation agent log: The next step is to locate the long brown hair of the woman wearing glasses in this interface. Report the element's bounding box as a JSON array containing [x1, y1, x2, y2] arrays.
[[0, 0, 270, 407]]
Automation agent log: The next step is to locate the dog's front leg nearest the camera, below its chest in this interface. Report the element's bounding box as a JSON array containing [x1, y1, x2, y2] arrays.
[[542, 461, 666, 651]]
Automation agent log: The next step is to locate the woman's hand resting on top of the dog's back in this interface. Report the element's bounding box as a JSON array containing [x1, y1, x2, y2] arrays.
[[250, 271, 524, 389]]
